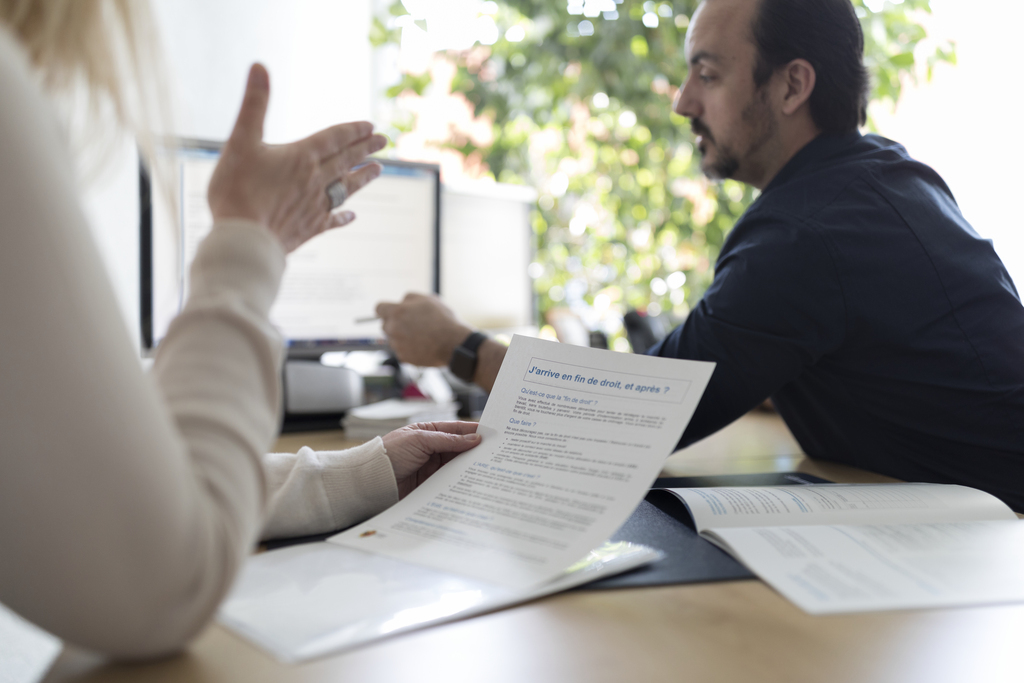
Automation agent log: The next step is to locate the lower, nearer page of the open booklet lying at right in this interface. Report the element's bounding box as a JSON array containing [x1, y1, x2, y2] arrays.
[[709, 520, 1024, 614]]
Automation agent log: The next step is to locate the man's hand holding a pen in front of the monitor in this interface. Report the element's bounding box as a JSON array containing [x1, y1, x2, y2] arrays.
[[377, 294, 473, 367]]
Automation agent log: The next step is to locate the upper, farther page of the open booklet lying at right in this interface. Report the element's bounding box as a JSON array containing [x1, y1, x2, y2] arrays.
[[666, 483, 1017, 531]]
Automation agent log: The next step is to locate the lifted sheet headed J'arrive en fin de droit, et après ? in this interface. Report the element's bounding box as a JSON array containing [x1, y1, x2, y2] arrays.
[[330, 336, 714, 588]]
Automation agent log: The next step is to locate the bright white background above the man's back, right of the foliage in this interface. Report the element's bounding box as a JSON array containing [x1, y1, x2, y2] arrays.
[[876, 0, 1024, 289]]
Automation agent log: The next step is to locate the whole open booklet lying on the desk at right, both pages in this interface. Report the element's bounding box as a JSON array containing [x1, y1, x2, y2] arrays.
[[666, 483, 1024, 614]]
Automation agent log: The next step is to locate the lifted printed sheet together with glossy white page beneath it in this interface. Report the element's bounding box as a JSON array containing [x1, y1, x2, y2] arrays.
[[220, 336, 714, 660]]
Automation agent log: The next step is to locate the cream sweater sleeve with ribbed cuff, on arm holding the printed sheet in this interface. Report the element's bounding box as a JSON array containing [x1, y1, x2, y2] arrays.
[[262, 436, 398, 540]]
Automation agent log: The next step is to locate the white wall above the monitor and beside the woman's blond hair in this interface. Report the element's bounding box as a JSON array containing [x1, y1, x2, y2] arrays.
[[84, 0, 372, 350]]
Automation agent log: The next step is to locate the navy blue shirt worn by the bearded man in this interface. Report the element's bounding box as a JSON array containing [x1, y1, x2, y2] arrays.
[[650, 133, 1024, 510]]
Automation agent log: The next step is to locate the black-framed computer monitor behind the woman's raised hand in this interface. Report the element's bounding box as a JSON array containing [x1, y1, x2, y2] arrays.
[[139, 140, 440, 357]]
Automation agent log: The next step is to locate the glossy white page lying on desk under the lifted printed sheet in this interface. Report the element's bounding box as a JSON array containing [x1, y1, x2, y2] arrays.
[[220, 542, 662, 663]]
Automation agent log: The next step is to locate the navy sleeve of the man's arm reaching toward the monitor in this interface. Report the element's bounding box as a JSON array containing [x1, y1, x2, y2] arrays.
[[648, 212, 846, 447]]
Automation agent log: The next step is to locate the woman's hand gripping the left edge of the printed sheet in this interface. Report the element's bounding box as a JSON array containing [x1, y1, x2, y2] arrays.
[[383, 422, 480, 499]]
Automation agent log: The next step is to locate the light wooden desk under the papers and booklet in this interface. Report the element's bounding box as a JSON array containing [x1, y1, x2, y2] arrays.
[[37, 414, 1024, 683]]
